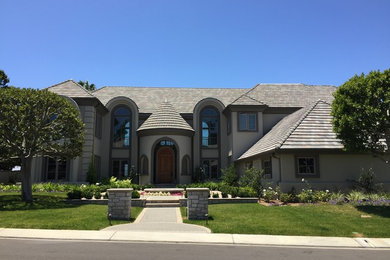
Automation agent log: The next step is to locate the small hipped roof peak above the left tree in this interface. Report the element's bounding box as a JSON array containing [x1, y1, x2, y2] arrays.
[[47, 79, 95, 98]]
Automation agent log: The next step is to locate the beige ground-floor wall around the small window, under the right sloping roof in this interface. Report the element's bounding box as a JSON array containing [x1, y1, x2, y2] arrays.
[[280, 153, 390, 192]]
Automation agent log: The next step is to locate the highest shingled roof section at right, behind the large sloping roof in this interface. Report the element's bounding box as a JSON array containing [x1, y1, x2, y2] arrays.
[[246, 83, 336, 107]]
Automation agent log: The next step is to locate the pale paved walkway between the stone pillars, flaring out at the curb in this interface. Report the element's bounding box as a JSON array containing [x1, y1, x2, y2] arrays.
[[102, 207, 211, 233]]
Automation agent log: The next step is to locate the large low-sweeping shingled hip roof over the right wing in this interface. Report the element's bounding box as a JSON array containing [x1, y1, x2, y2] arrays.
[[238, 100, 344, 160]]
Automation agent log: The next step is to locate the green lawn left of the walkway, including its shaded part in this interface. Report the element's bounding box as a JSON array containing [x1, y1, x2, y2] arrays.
[[0, 193, 142, 230]]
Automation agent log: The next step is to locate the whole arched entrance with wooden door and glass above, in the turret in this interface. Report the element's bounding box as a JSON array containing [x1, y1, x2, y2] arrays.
[[154, 139, 176, 184]]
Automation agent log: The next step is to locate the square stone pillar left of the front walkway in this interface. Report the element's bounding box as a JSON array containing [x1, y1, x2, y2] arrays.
[[107, 188, 133, 220]]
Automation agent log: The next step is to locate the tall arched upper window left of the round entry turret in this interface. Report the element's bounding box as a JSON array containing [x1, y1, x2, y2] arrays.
[[112, 106, 131, 148]]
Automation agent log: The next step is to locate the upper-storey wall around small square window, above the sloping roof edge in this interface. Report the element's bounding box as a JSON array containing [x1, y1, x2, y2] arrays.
[[231, 111, 263, 161]]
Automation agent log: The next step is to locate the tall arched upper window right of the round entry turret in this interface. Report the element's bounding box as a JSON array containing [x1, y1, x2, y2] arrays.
[[200, 107, 219, 148]]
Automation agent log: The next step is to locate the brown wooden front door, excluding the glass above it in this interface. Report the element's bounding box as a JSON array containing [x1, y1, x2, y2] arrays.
[[157, 147, 175, 183]]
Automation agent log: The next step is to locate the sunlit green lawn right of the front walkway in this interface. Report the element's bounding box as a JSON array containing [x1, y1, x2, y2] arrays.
[[182, 204, 390, 237]]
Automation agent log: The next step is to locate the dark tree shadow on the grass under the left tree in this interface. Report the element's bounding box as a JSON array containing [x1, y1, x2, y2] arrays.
[[0, 194, 80, 212]]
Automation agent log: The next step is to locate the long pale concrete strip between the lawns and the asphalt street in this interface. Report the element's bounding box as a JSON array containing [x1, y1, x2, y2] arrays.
[[0, 228, 390, 249]]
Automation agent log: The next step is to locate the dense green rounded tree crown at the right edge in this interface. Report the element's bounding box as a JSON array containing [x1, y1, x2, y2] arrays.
[[332, 69, 390, 154]]
